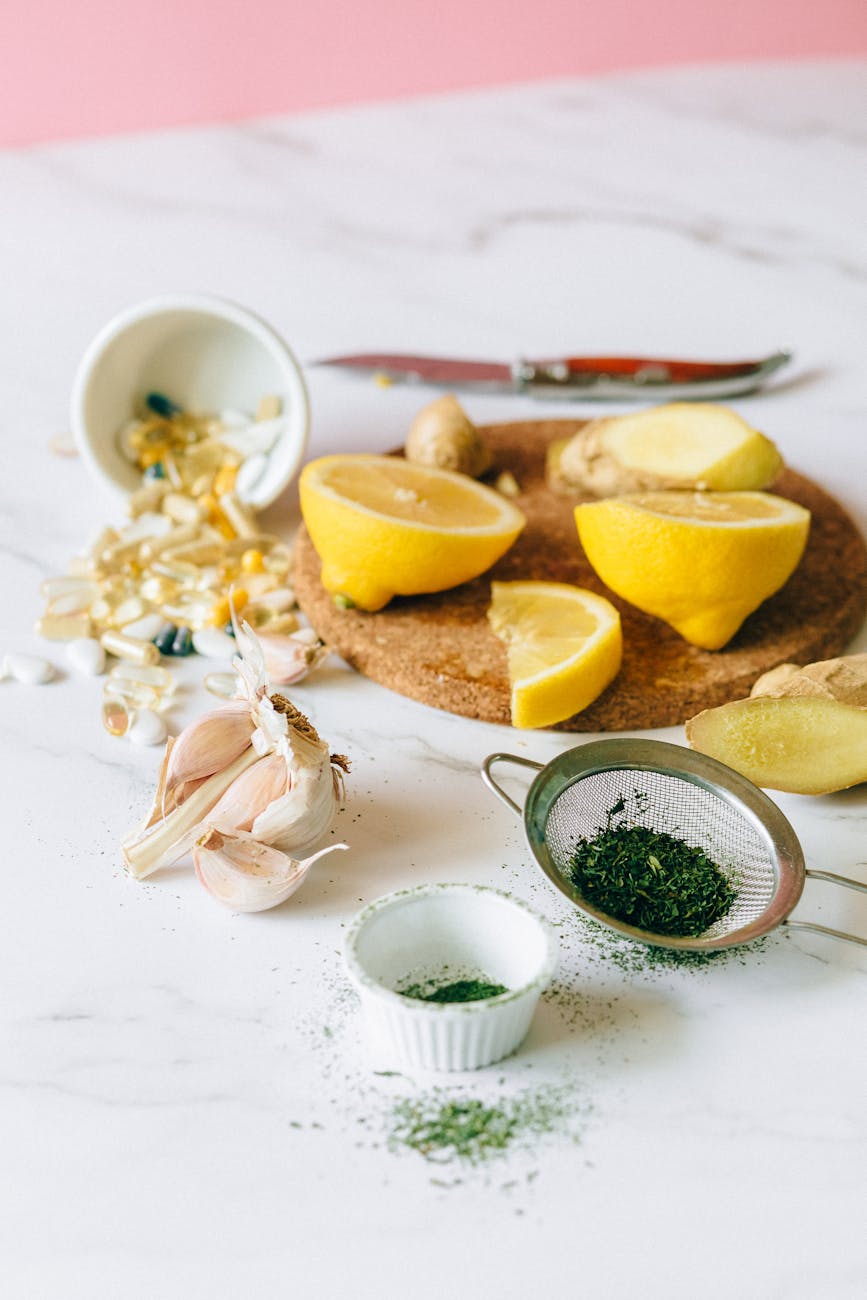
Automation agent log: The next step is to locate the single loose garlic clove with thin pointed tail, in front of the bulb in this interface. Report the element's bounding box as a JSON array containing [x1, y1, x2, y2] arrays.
[[192, 829, 348, 911]]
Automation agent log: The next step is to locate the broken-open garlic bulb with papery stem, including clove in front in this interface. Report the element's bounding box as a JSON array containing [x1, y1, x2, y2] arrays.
[[122, 623, 350, 911]]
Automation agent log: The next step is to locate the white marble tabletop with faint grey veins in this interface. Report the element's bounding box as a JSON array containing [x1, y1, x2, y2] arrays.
[[0, 62, 867, 1300]]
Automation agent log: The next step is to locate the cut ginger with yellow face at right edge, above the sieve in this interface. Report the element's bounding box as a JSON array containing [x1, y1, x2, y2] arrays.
[[686, 654, 867, 794]]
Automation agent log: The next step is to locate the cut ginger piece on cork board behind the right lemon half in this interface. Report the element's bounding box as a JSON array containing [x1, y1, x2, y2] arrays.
[[547, 402, 783, 497]]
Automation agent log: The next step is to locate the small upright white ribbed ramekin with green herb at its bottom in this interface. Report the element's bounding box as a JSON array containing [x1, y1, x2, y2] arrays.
[[344, 884, 556, 1070]]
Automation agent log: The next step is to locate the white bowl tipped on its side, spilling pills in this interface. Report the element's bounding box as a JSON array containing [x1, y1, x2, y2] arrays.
[[71, 294, 309, 507]]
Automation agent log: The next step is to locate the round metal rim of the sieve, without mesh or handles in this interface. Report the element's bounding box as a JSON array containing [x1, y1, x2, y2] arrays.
[[519, 737, 806, 952]]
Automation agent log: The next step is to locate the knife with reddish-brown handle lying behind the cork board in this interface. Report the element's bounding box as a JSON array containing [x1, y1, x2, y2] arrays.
[[312, 352, 792, 400]]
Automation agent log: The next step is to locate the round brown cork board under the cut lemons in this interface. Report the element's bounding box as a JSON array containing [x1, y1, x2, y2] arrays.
[[292, 420, 867, 732]]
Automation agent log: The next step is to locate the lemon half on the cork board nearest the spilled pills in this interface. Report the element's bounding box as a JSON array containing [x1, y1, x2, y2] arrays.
[[299, 455, 525, 610]]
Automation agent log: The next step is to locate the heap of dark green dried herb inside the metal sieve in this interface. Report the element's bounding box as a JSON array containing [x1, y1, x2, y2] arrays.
[[568, 800, 736, 939]]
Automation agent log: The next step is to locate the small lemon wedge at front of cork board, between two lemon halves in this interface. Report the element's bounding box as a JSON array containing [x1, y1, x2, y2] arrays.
[[487, 582, 623, 727]]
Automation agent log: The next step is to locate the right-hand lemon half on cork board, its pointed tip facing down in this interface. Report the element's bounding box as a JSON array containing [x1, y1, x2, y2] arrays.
[[575, 491, 810, 650]]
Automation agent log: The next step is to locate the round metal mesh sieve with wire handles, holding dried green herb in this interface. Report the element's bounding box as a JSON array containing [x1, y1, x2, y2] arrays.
[[481, 738, 867, 953]]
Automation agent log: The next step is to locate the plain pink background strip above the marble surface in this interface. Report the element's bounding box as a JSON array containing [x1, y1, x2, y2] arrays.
[[0, 0, 867, 144]]
